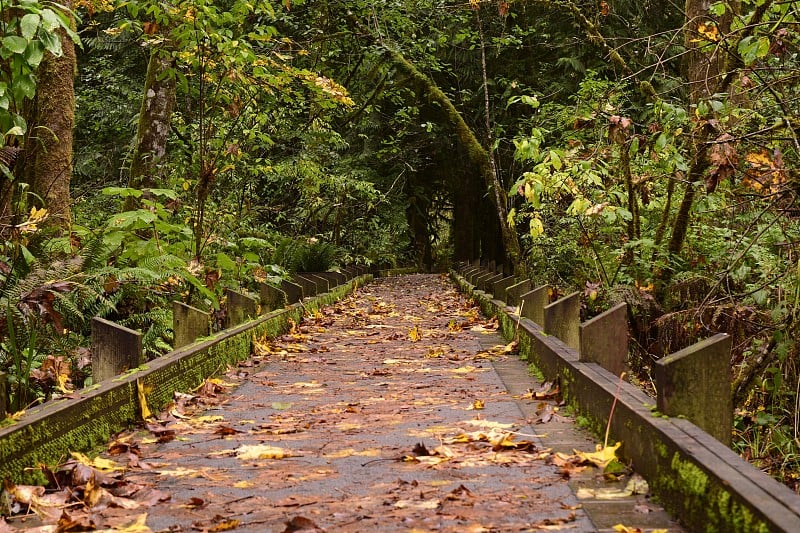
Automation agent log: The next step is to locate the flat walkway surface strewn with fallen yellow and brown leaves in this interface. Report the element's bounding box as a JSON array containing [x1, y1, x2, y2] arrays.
[[0, 275, 684, 532]]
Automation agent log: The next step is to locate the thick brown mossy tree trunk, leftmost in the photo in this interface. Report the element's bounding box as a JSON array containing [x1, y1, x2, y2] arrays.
[[22, 0, 77, 229]]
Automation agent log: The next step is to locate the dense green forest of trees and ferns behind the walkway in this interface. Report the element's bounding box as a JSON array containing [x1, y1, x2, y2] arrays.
[[0, 0, 800, 490]]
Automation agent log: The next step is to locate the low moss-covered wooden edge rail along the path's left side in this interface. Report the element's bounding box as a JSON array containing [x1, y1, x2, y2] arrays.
[[0, 267, 373, 484]]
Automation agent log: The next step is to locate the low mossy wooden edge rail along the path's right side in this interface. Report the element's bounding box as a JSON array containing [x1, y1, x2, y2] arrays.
[[451, 264, 800, 533]]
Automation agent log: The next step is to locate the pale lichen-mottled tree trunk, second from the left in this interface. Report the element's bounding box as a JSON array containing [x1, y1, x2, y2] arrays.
[[129, 49, 175, 189]]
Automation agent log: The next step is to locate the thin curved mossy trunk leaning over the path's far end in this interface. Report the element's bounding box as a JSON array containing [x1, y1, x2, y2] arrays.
[[387, 50, 527, 277]]
